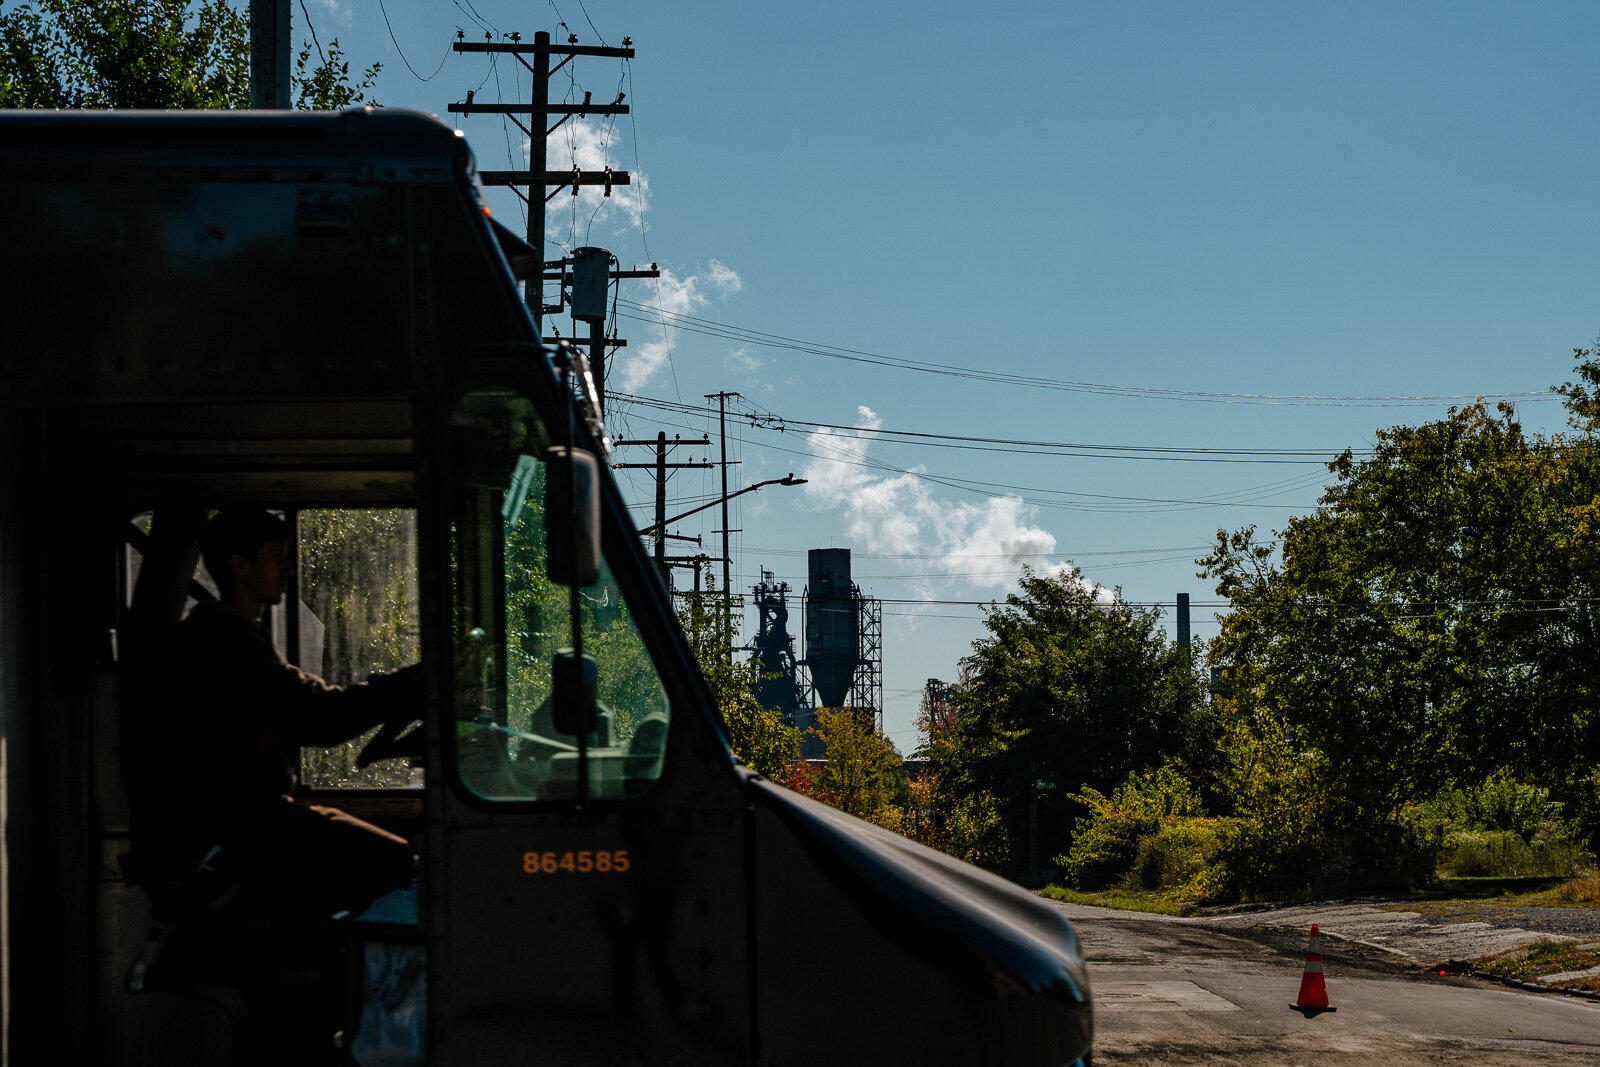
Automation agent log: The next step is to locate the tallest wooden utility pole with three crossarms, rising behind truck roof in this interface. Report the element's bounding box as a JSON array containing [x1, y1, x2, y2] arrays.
[[451, 33, 634, 327]]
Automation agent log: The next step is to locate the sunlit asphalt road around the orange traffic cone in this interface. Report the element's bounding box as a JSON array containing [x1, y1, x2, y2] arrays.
[[1061, 904, 1600, 1067]]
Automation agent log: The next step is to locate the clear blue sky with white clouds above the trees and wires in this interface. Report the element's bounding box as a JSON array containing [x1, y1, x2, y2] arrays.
[[305, 0, 1600, 750]]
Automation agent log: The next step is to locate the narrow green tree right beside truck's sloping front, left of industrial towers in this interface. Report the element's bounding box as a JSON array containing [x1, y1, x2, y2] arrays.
[[678, 568, 800, 782]]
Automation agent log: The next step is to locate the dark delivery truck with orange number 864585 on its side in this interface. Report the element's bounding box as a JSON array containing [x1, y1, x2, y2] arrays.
[[0, 110, 1091, 1067]]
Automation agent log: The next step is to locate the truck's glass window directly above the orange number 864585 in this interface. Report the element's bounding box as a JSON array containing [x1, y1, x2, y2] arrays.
[[450, 389, 670, 801]]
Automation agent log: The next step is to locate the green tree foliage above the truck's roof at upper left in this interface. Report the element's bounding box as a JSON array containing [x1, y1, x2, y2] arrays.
[[0, 0, 379, 110]]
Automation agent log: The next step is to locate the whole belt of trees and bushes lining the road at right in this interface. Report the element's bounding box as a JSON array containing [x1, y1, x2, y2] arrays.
[[930, 349, 1600, 907]]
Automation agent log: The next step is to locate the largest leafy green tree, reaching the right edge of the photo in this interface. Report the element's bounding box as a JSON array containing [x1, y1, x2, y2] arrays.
[[1200, 388, 1600, 825]]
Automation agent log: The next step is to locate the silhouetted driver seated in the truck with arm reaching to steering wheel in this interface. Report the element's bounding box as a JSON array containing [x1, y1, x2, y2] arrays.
[[146, 509, 421, 923]]
